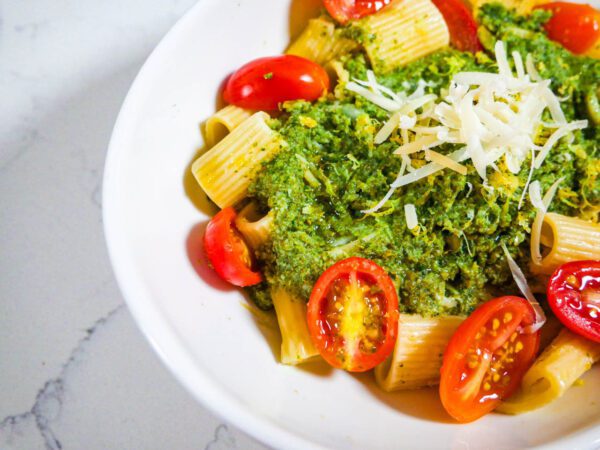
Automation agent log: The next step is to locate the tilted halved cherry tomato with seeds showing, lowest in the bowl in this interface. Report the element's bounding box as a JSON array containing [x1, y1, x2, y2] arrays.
[[440, 296, 540, 422]]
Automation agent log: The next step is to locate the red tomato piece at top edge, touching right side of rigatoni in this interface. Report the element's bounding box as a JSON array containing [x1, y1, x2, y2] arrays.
[[433, 0, 483, 53]]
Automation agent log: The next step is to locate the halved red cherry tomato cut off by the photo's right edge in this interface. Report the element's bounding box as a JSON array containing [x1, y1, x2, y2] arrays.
[[547, 261, 600, 343]]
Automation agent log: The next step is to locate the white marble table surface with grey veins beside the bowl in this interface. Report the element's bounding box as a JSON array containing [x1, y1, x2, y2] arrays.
[[0, 0, 264, 450]]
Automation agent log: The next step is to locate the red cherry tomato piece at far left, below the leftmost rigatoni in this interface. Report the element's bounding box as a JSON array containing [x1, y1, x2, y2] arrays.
[[204, 206, 262, 286]]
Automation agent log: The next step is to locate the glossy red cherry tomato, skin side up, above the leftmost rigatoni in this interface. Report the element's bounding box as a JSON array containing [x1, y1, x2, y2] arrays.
[[223, 55, 329, 111]]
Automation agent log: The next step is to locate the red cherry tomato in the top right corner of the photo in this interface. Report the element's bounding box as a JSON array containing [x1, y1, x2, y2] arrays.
[[536, 2, 600, 54]]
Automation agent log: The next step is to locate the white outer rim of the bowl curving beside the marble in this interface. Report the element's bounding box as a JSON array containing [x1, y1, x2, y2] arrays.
[[102, 0, 600, 450]]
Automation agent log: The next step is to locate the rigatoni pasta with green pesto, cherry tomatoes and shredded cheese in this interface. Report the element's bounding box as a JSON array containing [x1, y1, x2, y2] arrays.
[[192, 0, 600, 422]]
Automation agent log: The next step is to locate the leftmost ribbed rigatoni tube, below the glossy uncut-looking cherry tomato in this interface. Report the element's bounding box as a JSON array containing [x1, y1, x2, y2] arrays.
[[192, 112, 284, 208]]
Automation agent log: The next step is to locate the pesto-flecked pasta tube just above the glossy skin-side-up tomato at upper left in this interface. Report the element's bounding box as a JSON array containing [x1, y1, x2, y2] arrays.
[[286, 18, 358, 65]]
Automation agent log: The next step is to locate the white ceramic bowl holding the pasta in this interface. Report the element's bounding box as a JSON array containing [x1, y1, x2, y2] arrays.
[[104, 0, 600, 449]]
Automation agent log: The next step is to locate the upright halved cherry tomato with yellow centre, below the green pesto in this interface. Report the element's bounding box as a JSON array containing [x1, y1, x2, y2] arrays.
[[307, 257, 398, 372]]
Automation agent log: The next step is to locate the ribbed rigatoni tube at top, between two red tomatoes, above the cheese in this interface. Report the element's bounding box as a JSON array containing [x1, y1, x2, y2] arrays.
[[361, 0, 450, 72]]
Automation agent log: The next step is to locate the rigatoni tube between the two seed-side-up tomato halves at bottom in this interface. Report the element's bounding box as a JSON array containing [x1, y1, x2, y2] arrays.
[[375, 314, 465, 392]]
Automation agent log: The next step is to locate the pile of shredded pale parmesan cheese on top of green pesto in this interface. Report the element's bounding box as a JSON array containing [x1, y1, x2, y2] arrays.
[[346, 41, 587, 213]]
